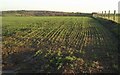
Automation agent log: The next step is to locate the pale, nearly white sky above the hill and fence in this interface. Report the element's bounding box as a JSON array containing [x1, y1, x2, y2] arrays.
[[0, 0, 120, 13]]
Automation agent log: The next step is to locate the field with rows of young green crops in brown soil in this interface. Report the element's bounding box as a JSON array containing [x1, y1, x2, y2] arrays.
[[2, 17, 118, 73]]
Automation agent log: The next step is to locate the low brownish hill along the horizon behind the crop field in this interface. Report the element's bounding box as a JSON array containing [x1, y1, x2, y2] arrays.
[[2, 10, 91, 16]]
